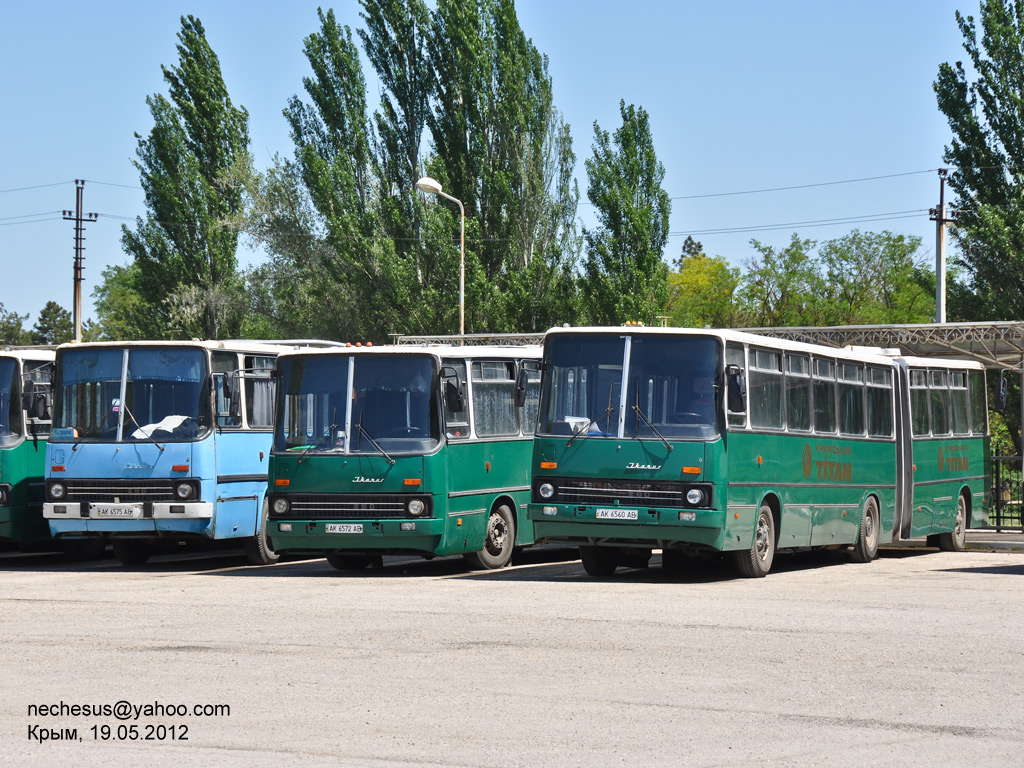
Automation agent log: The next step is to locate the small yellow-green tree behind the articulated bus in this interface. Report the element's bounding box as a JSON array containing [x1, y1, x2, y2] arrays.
[[665, 238, 739, 328]]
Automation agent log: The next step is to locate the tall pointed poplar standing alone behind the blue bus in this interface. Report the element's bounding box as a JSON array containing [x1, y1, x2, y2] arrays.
[[117, 16, 249, 338]]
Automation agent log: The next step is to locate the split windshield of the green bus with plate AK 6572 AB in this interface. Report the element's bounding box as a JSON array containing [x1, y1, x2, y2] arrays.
[[274, 354, 440, 455]]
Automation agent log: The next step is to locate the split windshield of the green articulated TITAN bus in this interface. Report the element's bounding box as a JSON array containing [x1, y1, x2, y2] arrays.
[[539, 334, 722, 439]]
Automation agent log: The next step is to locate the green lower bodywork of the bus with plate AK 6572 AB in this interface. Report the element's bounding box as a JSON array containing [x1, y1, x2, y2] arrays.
[[267, 438, 534, 555]]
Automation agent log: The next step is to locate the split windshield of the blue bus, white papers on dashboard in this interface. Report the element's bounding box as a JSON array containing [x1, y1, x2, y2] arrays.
[[53, 347, 211, 442]]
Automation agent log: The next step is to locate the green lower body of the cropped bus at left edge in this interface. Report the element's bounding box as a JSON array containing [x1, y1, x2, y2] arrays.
[[0, 437, 50, 545]]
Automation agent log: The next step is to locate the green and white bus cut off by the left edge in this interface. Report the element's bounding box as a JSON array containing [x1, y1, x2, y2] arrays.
[[0, 347, 53, 548]]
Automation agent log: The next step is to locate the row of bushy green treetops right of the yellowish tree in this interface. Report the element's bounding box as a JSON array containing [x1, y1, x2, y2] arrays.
[[737, 229, 935, 327]]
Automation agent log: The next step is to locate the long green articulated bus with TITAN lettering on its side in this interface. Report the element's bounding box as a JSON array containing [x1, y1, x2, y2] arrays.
[[528, 328, 989, 577]]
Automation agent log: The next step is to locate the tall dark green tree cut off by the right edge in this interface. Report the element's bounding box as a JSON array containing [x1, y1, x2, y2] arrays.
[[934, 0, 1024, 319]]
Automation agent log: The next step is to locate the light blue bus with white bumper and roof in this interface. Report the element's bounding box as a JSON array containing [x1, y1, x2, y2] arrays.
[[43, 341, 317, 565]]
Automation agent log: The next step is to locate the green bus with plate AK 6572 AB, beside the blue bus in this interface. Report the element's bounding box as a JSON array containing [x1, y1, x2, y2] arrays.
[[267, 345, 541, 570]]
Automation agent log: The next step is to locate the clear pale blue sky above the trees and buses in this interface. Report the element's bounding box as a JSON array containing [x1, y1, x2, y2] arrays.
[[0, 0, 978, 329]]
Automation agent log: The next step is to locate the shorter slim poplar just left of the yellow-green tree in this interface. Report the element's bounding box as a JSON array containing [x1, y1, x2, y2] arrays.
[[583, 101, 672, 325]]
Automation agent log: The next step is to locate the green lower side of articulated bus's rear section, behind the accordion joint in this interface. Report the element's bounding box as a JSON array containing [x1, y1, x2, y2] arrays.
[[910, 435, 991, 537]]
